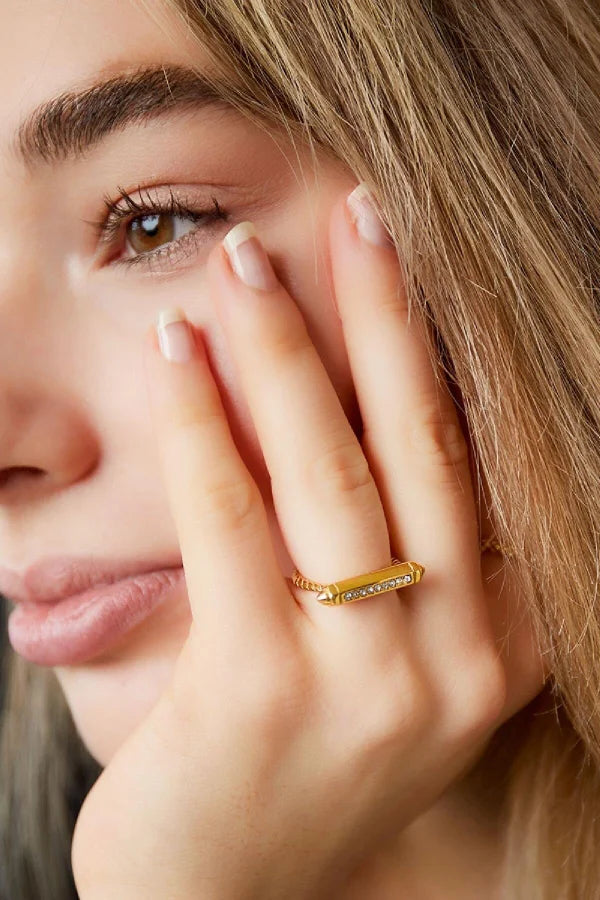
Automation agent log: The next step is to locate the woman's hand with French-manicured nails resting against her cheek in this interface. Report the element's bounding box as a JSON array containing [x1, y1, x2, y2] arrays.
[[72, 185, 544, 900]]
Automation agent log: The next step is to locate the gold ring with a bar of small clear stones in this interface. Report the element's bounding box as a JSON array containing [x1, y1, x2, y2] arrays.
[[292, 537, 506, 606]]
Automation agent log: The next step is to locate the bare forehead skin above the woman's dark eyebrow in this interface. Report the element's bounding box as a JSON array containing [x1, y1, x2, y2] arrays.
[[0, 0, 213, 171]]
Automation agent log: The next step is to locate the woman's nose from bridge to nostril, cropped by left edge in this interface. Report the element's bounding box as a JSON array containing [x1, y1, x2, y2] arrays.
[[0, 175, 99, 520]]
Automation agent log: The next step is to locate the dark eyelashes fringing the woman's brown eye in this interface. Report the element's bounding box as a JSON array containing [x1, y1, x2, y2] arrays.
[[88, 187, 228, 268]]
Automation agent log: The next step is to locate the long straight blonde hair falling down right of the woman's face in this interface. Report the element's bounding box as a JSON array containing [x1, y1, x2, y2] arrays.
[[0, 0, 600, 900]]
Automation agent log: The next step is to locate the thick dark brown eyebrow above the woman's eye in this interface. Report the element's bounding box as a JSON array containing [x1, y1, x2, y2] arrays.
[[11, 65, 237, 169]]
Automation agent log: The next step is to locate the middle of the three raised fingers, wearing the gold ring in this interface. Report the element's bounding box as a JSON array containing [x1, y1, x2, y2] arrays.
[[207, 222, 408, 645]]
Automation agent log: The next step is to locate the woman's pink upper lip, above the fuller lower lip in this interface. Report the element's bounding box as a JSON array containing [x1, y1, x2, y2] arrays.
[[0, 556, 181, 603]]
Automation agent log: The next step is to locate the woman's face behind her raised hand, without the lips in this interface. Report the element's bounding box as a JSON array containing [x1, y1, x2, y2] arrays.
[[0, 0, 360, 765]]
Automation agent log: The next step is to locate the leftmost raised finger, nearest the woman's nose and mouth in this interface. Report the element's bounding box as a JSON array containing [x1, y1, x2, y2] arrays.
[[144, 308, 293, 639]]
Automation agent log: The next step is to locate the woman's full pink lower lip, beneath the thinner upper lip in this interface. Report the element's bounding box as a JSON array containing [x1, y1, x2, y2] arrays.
[[8, 567, 185, 666]]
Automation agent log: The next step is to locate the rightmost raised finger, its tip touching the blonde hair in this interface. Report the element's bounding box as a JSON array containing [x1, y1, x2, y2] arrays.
[[330, 187, 479, 584]]
